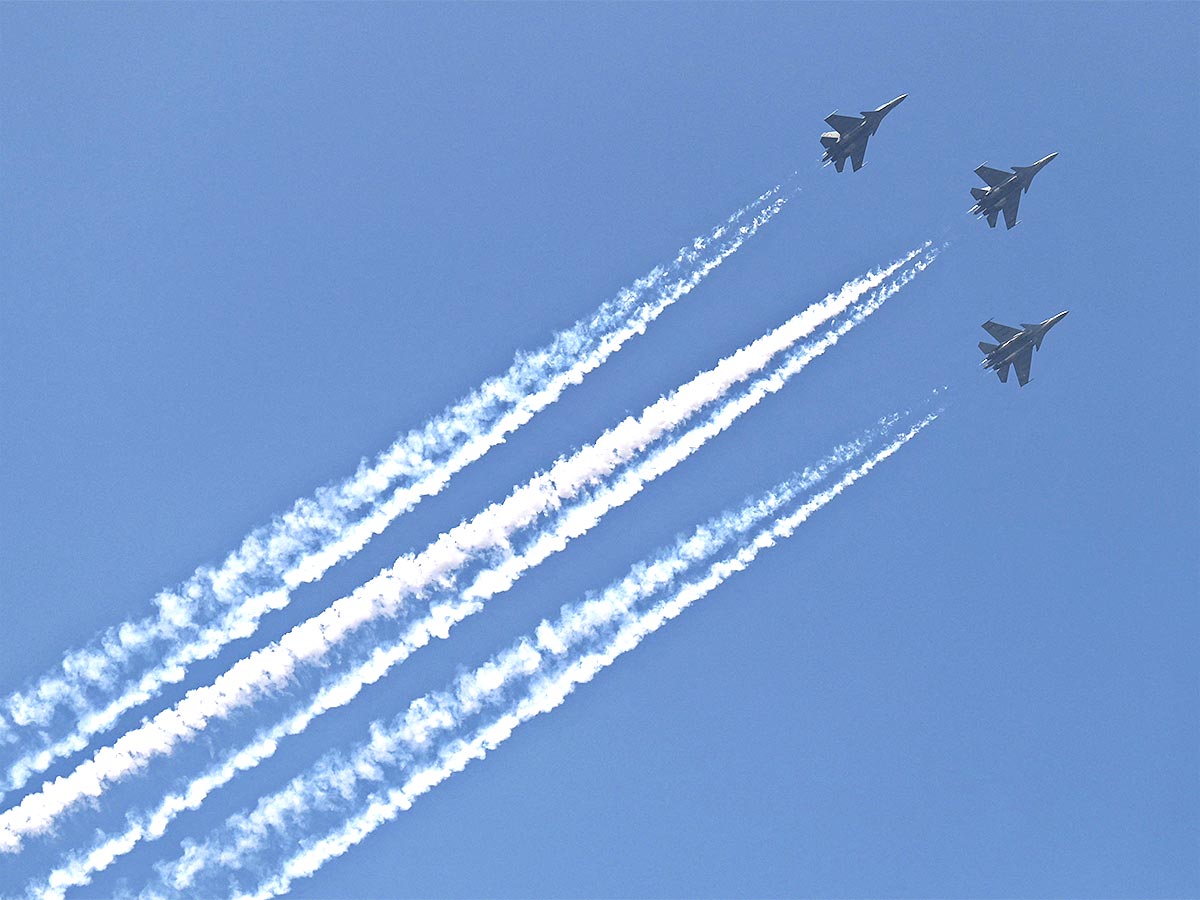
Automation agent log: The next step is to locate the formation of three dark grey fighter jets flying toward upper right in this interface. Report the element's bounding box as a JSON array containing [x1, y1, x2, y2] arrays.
[[821, 94, 1069, 388]]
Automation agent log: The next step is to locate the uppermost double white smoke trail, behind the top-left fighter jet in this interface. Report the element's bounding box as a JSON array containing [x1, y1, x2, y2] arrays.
[[0, 186, 787, 796]]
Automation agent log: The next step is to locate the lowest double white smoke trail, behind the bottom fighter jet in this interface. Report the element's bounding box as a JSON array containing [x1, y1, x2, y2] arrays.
[[148, 410, 941, 900]]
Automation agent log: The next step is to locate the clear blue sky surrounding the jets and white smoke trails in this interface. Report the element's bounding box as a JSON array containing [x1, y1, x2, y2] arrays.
[[0, 4, 1200, 898]]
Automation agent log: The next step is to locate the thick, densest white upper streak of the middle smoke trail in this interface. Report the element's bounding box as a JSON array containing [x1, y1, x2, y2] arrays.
[[0, 245, 936, 852]]
